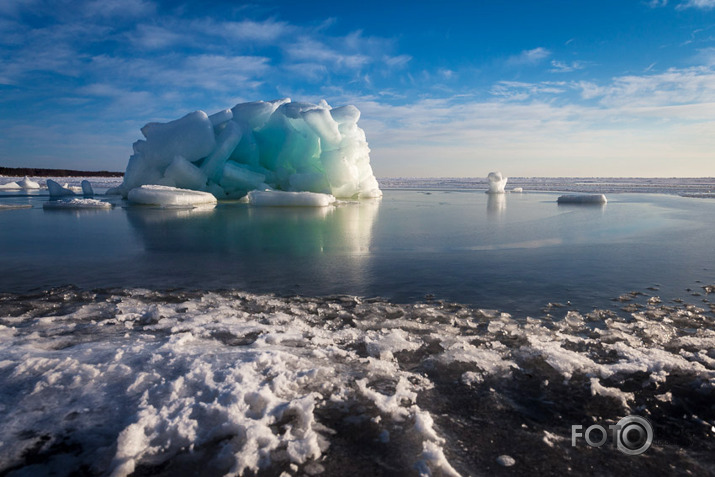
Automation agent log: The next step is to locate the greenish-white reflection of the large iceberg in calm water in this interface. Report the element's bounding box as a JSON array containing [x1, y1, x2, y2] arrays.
[[125, 199, 380, 294]]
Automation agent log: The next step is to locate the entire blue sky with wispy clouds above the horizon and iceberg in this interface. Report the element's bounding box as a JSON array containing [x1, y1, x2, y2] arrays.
[[0, 0, 715, 177]]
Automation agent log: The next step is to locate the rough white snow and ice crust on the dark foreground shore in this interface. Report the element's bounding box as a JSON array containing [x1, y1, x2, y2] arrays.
[[0, 286, 715, 475]]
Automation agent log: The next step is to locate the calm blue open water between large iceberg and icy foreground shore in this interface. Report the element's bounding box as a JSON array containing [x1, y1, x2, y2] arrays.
[[0, 190, 715, 314]]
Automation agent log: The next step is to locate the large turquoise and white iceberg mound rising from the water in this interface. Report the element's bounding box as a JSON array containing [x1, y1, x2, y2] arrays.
[[110, 98, 382, 202]]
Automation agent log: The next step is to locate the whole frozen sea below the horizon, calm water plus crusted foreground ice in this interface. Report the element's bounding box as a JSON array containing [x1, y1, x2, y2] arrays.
[[0, 178, 715, 476]]
